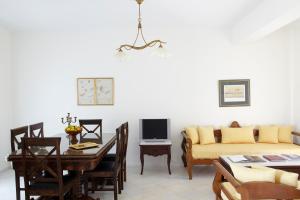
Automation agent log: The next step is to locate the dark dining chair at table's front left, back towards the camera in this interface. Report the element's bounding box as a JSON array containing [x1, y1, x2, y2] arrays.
[[22, 138, 77, 200]]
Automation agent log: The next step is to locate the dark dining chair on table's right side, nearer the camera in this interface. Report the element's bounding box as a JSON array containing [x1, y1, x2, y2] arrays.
[[84, 127, 122, 200]]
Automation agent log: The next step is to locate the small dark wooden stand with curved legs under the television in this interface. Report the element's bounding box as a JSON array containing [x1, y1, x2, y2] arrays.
[[140, 141, 172, 175]]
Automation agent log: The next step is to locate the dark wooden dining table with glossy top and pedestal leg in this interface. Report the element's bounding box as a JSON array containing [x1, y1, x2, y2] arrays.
[[7, 133, 116, 199]]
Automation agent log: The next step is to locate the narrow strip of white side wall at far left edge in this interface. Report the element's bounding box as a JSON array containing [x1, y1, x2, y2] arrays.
[[0, 26, 12, 170]]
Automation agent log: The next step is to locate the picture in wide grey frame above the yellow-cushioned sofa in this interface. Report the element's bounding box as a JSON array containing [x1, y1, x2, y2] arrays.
[[219, 79, 250, 107]]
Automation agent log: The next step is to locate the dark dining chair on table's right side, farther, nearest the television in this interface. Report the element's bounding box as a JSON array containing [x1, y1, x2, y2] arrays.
[[103, 122, 129, 186]]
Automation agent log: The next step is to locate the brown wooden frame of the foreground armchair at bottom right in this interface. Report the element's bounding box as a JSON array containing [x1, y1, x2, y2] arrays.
[[213, 161, 300, 200]]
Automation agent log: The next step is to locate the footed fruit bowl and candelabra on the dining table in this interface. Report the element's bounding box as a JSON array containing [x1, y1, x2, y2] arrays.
[[61, 113, 82, 144]]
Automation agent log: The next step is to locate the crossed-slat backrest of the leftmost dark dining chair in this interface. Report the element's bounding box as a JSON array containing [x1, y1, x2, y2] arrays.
[[10, 126, 28, 152]]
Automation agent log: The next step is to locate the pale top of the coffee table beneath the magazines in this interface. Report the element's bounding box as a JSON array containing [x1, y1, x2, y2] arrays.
[[220, 154, 300, 167]]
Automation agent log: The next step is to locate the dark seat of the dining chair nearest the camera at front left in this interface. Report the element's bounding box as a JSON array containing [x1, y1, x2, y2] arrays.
[[29, 175, 76, 191]]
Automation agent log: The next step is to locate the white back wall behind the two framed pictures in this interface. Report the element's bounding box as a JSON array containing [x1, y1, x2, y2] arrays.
[[13, 28, 291, 168]]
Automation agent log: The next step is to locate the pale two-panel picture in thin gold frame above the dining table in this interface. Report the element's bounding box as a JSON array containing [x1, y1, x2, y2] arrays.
[[77, 77, 114, 105]]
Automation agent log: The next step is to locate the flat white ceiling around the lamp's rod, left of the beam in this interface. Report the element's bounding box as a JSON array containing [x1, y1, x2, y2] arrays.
[[0, 0, 263, 30]]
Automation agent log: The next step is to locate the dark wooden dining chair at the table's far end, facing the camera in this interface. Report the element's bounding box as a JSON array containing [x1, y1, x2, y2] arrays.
[[79, 119, 102, 143]]
